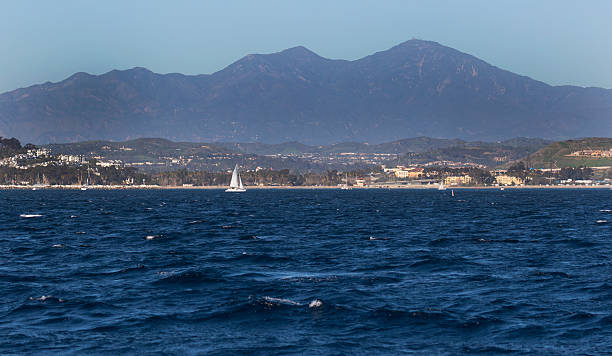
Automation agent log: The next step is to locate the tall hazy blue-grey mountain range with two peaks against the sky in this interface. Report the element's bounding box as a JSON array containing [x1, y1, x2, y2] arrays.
[[0, 40, 612, 145]]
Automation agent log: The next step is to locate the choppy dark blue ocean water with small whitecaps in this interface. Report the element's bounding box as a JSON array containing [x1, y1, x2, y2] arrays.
[[0, 189, 612, 355]]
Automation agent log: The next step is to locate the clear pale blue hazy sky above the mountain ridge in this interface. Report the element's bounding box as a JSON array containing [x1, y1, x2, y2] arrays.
[[0, 0, 612, 92]]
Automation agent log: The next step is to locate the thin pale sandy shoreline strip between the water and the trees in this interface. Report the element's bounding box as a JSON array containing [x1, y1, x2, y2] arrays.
[[0, 184, 612, 191]]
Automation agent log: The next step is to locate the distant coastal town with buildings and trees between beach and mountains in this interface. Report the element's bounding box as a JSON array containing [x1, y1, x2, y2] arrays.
[[0, 138, 612, 188]]
